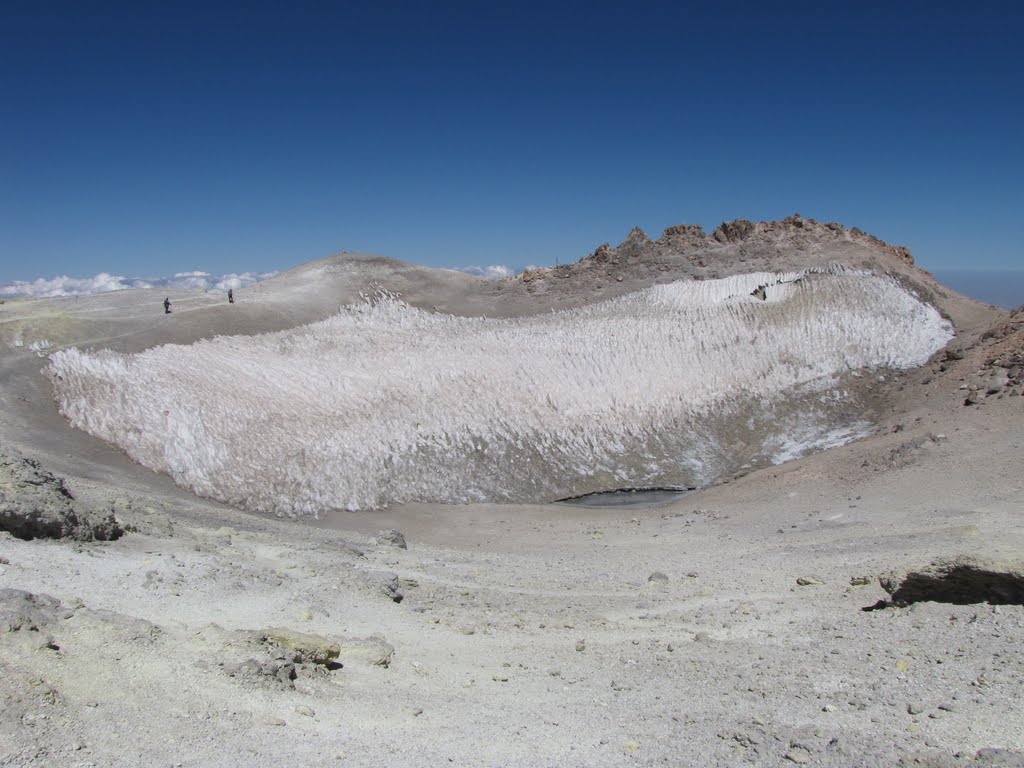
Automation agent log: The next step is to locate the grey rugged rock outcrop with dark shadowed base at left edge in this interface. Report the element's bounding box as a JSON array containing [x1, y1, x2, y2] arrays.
[[0, 450, 124, 542]]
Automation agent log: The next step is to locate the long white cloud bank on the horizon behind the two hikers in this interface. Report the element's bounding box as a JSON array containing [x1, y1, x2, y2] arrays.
[[0, 270, 276, 298]]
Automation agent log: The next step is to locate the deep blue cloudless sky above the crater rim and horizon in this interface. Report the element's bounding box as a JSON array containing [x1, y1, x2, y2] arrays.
[[0, 0, 1024, 282]]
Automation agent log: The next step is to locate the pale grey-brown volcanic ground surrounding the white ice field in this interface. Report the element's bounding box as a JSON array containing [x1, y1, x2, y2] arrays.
[[0, 219, 1024, 766]]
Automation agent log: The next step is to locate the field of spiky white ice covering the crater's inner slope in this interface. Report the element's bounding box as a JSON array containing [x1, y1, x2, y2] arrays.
[[49, 270, 951, 515]]
